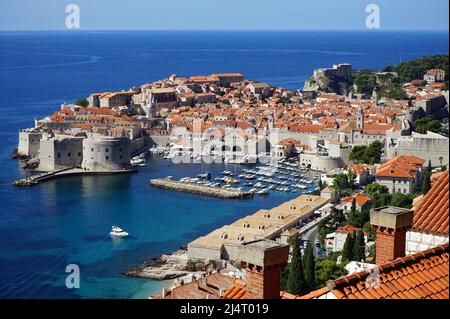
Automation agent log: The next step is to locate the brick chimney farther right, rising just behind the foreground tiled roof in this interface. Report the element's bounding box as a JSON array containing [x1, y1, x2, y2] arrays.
[[370, 206, 413, 265]]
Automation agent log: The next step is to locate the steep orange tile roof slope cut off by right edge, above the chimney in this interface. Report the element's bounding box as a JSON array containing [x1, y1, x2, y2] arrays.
[[412, 170, 449, 236]]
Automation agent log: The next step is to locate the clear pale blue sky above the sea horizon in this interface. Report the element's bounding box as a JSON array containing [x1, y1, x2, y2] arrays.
[[0, 0, 449, 30]]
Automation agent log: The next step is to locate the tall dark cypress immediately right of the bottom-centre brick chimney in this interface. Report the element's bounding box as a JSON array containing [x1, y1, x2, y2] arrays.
[[286, 236, 306, 295]]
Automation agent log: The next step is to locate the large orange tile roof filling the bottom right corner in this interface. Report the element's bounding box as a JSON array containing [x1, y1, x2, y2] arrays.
[[302, 243, 449, 299]]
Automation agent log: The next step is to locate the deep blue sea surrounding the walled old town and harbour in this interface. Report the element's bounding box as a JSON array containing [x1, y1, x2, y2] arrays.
[[0, 31, 448, 298]]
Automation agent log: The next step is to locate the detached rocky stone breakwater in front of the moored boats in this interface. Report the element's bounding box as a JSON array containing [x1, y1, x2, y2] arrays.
[[150, 179, 253, 199]]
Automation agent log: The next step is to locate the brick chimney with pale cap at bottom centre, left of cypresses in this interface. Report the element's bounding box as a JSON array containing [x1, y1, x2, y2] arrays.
[[239, 239, 289, 299]]
